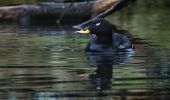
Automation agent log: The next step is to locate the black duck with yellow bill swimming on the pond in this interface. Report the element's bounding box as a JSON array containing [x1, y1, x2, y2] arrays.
[[76, 18, 134, 52]]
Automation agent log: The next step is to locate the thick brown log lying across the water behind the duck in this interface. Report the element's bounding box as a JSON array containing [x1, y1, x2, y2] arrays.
[[0, 0, 135, 22]]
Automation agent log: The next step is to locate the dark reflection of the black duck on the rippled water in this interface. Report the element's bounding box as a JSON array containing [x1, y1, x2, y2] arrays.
[[87, 51, 134, 90]]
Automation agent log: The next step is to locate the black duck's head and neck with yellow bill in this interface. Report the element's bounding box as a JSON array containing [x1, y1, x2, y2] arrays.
[[77, 18, 114, 44]]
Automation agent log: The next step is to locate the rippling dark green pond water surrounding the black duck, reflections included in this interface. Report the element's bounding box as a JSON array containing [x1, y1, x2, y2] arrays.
[[0, 0, 170, 100]]
